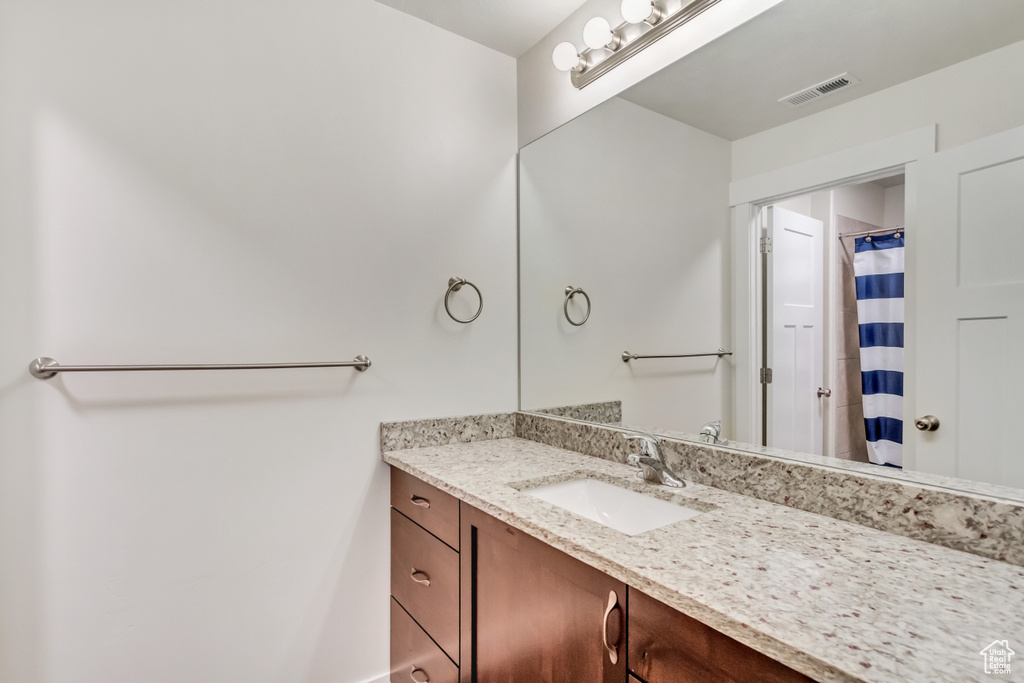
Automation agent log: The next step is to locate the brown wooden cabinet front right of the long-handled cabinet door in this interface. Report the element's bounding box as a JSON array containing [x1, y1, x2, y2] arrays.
[[627, 588, 812, 683]]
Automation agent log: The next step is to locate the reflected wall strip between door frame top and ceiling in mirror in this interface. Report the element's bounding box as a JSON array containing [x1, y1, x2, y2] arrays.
[[732, 42, 1024, 180]]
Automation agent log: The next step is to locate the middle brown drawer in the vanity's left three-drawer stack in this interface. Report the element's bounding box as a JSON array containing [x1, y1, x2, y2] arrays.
[[391, 508, 459, 663]]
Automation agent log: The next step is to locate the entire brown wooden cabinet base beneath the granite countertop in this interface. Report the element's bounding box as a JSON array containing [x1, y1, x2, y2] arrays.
[[391, 469, 811, 683]]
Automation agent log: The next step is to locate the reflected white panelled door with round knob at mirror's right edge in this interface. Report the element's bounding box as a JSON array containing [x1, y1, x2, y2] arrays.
[[917, 127, 1024, 487]]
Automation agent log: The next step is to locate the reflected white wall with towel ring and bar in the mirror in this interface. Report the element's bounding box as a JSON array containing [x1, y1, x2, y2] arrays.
[[519, 98, 731, 432]]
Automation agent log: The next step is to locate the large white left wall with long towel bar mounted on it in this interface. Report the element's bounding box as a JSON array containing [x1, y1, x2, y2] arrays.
[[0, 0, 516, 683]]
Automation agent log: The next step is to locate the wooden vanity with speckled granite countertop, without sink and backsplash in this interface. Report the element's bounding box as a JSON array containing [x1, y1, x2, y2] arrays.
[[383, 413, 1024, 683]]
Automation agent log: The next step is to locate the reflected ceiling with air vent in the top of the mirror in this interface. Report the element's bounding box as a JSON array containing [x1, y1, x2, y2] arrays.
[[620, 0, 1024, 140]]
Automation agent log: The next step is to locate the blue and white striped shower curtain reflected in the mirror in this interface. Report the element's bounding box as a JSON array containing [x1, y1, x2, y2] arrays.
[[853, 231, 904, 467]]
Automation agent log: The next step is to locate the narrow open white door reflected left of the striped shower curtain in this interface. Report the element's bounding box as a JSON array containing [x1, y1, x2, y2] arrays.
[[767, 207, 824, 455]]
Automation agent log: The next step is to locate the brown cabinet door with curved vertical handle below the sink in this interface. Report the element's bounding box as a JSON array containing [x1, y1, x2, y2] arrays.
[[461, 503, 626, 683]]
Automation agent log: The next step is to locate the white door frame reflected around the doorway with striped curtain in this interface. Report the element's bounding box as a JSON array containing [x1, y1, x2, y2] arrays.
[[729, 124, 936, 469]]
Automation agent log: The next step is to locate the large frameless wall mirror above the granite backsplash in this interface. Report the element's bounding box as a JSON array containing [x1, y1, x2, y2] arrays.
[[519, 0, 1024, 500]]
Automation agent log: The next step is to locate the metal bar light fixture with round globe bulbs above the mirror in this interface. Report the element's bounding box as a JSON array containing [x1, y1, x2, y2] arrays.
[[551, 0, 720, 89]]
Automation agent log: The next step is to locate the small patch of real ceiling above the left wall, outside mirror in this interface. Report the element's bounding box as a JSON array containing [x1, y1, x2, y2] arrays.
[[377, 0, 586, 58]]
